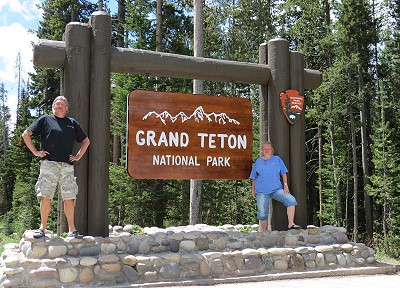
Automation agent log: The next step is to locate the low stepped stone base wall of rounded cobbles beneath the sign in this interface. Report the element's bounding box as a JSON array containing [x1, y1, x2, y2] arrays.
[[0, 225, 376, 287]]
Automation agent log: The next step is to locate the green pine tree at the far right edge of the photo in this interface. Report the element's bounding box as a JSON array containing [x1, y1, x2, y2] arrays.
[[368, 1, 400, 257]]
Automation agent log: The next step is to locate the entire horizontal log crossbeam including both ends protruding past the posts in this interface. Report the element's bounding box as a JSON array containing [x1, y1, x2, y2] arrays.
[[33, 39, 322, 89]]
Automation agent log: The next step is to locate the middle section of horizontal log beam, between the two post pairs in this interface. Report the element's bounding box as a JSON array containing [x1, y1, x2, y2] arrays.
[[111, 48, 270, 85]]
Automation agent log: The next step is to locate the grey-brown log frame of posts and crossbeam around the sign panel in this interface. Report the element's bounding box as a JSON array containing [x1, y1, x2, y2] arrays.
[[33, 7, 322, 237]]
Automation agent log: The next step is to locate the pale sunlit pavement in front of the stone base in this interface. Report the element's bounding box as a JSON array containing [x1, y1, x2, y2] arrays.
[[124, 265, 400, 288]]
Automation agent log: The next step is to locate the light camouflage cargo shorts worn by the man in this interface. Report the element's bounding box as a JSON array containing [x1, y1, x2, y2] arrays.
[[35, 160, 78, 200]]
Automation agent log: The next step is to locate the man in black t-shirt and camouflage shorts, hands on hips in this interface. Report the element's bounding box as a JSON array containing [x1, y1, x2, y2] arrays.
[[22, 96, 90, 238]]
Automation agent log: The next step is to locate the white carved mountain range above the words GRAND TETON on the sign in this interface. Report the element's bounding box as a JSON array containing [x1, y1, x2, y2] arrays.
[[142, 106, 240, 125]]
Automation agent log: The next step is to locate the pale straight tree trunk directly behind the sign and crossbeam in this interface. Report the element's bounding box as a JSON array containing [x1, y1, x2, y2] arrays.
[[190, 0, 204, 225]]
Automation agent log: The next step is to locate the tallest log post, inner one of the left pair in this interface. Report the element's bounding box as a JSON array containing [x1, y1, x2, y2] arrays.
[[88, 12, 111, 237]]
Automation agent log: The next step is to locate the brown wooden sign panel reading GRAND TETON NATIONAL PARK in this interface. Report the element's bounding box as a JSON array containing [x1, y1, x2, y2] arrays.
[[127, 90, 253, 180]]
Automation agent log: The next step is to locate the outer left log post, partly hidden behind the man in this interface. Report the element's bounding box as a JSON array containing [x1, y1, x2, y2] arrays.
[[63, 22, 90, 235]]
